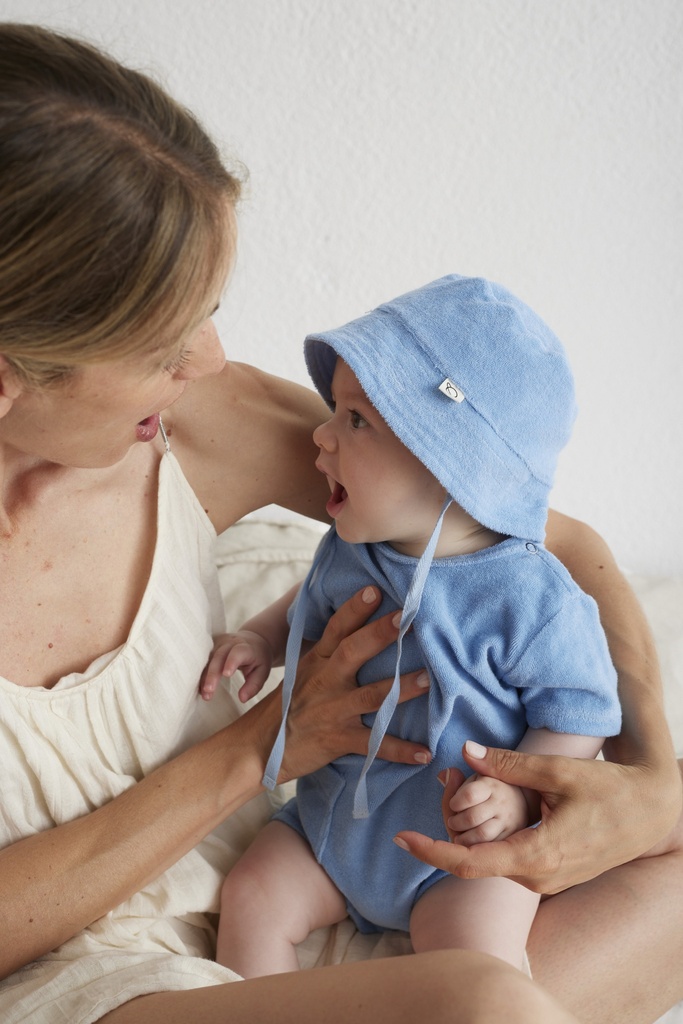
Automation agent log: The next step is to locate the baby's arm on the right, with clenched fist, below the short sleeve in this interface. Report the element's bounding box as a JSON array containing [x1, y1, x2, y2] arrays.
[[449, 729, 604, 846]]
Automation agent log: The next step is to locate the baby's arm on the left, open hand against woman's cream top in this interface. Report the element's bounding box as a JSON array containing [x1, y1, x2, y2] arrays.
[[200, 584, 299, 702]]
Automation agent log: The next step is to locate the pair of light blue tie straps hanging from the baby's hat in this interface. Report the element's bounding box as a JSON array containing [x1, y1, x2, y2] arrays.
[[263, 497, 453, 818]]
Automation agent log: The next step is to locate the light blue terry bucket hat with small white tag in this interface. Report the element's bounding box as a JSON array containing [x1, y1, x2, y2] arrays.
[[305, 274, 575, 542]]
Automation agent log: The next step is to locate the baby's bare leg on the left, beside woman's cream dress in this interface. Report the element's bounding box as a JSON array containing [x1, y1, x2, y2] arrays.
[[216, 821, 346, 978]]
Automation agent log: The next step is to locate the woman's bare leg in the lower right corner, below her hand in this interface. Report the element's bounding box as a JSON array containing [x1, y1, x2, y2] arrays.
[[528, 786, 683, 1024]]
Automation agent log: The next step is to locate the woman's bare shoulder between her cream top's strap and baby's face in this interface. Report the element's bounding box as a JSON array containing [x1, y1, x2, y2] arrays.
[[164, 362, 328, 530]]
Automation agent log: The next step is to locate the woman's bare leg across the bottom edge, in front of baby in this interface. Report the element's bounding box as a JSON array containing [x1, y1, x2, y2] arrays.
[[100, 950, 578, 1024]]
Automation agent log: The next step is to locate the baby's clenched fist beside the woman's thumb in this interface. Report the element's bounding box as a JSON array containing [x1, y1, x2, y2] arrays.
[[449, 775, 529, 846]]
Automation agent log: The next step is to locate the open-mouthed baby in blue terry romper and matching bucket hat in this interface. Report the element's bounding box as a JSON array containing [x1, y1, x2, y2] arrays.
[[203, 274, 621, 977]]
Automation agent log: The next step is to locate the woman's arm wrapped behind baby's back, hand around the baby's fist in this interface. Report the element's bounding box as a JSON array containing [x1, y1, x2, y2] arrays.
[[400, 513, 681, 893]]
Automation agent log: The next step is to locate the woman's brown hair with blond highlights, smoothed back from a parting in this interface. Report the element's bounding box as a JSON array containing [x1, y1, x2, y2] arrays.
[[0, 24, 241, 386]]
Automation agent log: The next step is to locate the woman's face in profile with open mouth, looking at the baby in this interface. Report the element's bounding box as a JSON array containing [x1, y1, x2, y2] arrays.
[[0, 317, 225, 468]]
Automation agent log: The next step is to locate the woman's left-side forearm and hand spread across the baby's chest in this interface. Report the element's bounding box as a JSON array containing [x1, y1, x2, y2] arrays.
[[0, 588, 426, 977]]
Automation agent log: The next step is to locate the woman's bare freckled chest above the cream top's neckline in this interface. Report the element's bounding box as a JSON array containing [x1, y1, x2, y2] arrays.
[[0, 464, 157, 687]]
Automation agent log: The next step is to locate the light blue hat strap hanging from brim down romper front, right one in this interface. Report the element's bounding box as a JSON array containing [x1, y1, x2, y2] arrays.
[[353, 496, 453, 818]]
